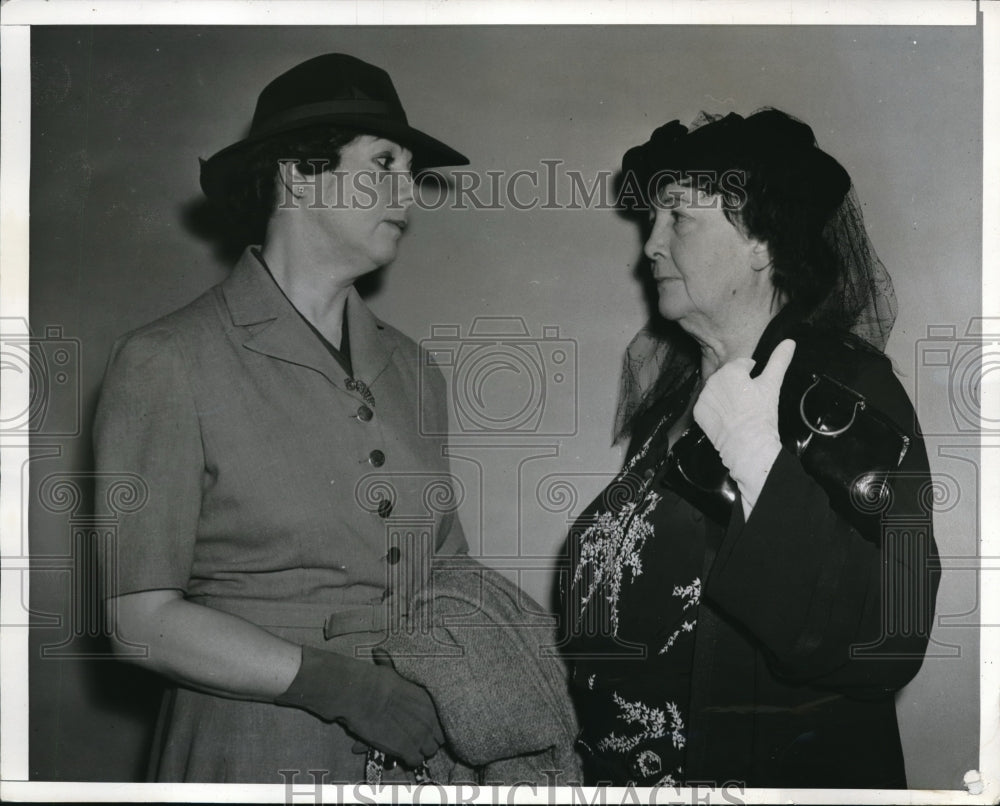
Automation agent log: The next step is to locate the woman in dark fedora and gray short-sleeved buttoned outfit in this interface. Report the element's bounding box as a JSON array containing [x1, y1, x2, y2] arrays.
[[94, 54, 468, 783]]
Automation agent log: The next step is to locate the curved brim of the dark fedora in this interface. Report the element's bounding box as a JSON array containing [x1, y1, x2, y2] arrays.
[[201, 114, 469, 201]]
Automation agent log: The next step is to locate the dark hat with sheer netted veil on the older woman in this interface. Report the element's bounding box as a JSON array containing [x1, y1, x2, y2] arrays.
[[614, 109, 896, 441]]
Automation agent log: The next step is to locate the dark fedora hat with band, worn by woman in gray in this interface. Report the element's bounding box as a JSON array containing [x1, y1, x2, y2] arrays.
[[201, 53, 469, 199]]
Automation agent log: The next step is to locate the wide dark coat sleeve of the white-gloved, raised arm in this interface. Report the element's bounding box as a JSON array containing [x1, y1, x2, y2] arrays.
[[704, 361, 939, 697]]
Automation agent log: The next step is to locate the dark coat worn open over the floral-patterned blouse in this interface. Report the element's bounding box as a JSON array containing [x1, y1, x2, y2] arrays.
[[564, 316, 939, 788]]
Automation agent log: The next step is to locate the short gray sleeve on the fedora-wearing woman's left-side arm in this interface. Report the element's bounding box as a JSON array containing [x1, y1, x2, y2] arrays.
[[94, 327, 204, 596]]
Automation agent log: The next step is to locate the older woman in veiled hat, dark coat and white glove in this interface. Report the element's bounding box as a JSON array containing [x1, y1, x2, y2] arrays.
[[563, 109, 938, 788]]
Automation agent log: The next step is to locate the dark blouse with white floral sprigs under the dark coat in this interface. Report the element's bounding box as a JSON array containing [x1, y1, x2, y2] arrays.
[[563, 378, 705, 786]]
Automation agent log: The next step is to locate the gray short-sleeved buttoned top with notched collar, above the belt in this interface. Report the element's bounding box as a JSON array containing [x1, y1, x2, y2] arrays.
[[94, 249, 466, 612]]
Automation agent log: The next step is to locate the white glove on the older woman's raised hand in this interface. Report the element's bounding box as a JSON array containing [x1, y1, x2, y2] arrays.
[[694, 339, 795, 518]]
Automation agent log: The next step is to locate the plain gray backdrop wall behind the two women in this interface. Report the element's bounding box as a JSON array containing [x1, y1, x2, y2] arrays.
[[28, 26, 982, 789]]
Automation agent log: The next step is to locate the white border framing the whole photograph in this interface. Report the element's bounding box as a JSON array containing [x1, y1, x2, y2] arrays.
[[0, 0, 1000, 804]]
